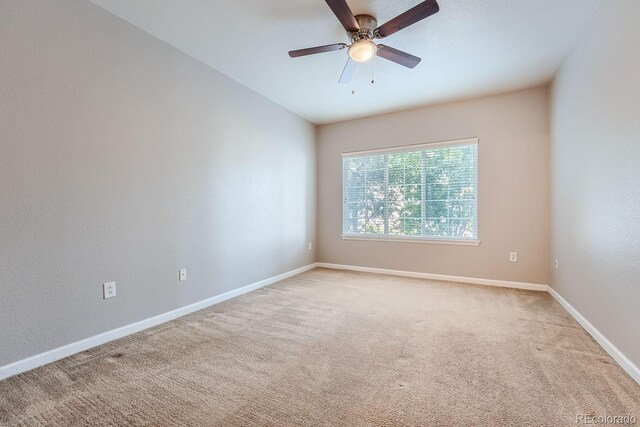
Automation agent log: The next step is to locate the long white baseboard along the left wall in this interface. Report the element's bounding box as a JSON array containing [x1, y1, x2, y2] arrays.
[[0, 263, 316, 380]]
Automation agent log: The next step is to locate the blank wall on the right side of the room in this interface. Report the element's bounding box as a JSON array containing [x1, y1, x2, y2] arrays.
[[551, 0, 640, 366]]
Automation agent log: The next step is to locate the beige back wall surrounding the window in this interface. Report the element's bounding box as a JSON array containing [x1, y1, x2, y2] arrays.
[[318, 87, 549, 284]]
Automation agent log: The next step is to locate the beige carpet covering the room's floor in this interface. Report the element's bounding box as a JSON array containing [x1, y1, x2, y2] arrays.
[[0, 269, 640, 426]]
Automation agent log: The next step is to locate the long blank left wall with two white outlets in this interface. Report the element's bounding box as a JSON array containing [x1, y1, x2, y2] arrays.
[[0, 0, 316, 366]]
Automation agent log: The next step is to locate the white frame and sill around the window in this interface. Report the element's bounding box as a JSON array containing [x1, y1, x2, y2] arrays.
[[340, 138, 480, 246]]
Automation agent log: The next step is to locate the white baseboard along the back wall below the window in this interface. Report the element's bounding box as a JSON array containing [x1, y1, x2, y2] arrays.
[[316, 262, 549, 292]]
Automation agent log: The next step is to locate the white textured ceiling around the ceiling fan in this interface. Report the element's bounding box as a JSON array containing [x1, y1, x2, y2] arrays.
[[92, 0, 600, 124]]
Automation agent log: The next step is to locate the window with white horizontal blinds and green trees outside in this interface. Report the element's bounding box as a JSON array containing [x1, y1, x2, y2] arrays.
[[342, 139, 478, 242]]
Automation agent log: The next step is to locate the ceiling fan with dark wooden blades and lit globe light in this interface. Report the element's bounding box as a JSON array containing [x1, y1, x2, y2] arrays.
[[289, 0, 440, 83]]
